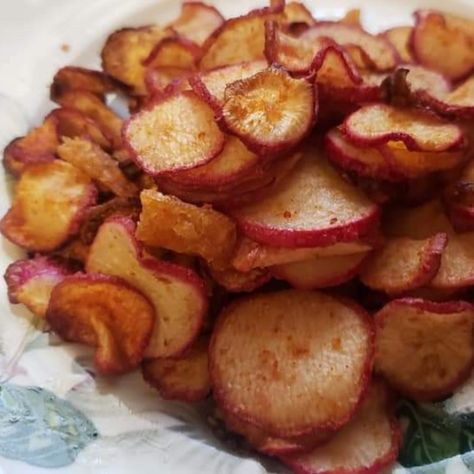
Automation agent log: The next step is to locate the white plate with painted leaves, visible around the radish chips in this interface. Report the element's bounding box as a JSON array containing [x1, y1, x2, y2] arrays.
[[0, 0, 474, 474]]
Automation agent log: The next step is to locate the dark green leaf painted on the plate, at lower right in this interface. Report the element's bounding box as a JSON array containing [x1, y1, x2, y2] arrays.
[[398, 400, 474, 467]]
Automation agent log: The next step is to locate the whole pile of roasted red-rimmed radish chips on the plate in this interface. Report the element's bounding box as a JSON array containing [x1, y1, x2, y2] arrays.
[[0, 0, 474, 474]]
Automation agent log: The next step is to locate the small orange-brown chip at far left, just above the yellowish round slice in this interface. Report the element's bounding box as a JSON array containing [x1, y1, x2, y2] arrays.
[[3, 116, 59, 176]]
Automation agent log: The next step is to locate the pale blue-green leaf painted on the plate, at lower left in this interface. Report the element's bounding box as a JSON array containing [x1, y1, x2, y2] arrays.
[[0, 384, 98, 468]]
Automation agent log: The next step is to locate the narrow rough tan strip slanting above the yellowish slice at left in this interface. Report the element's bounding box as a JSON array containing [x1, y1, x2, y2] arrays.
[[58, 138, 138, 197]]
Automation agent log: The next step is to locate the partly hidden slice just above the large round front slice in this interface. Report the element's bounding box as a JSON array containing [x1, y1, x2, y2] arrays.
[[270, 253, 367, 290]]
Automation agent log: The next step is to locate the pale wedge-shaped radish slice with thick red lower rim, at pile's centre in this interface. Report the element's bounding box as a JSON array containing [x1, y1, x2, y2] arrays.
[[232, 148, 379, 247]]
